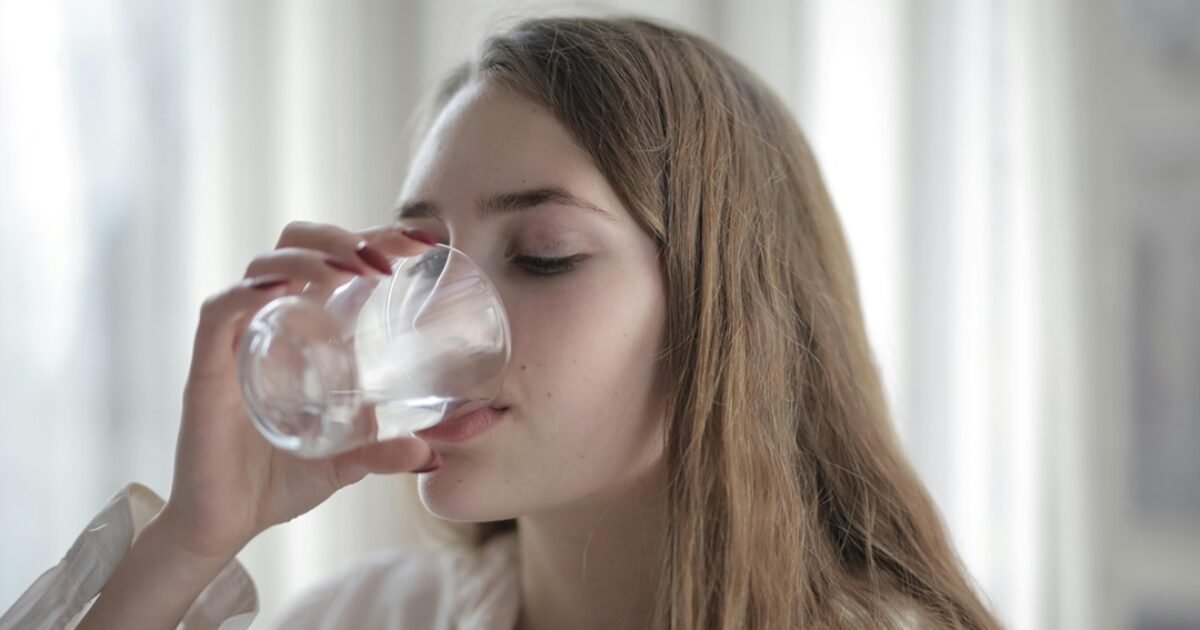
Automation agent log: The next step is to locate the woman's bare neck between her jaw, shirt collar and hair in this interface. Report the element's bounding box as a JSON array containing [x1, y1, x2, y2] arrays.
[[517, 463, 666, 630]]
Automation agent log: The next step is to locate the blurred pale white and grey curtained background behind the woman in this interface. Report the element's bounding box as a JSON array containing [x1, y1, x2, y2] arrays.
[[0, 0, 1200, 630]]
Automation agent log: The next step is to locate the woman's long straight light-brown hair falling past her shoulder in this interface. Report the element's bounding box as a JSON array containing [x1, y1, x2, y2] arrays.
[[412, 12, 998, 629]]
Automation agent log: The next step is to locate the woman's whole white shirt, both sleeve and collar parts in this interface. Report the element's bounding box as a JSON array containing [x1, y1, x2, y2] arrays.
[[0, 484, 520, 630]]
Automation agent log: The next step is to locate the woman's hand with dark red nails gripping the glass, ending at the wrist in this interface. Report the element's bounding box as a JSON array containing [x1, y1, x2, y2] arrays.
[[158, 223, 437, 557]]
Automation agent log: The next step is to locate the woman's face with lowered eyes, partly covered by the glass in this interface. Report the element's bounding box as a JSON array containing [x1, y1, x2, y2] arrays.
[[401, 82, 665, 521]]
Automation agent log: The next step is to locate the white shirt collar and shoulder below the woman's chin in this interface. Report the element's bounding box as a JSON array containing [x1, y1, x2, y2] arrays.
[[277, 533, 520, 629]]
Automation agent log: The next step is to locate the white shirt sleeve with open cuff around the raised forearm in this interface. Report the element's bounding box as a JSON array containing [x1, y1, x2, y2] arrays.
[[0, 484, 258, 630]]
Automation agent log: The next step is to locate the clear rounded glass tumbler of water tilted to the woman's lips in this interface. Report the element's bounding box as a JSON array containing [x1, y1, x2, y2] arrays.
[[238, 244, 510, 457]]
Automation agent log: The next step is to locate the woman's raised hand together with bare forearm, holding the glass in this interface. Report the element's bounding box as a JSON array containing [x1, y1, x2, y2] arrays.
[[78, 223, 439, 630]]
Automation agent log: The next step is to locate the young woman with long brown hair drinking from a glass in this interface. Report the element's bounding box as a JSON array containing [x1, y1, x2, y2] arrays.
[[11, 12, 998, 629]]
